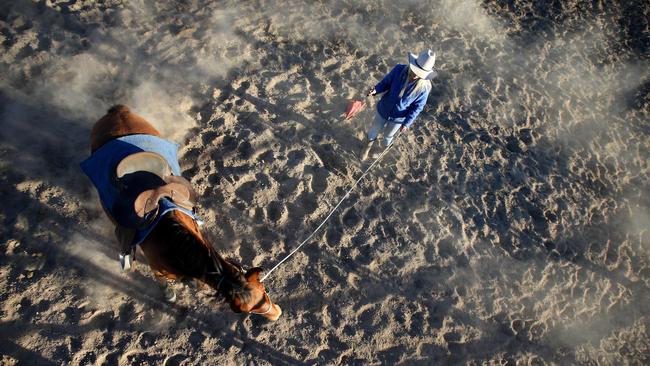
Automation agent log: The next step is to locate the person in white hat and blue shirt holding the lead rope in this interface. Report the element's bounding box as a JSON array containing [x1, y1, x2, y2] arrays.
[[361, 50, 438, 160]]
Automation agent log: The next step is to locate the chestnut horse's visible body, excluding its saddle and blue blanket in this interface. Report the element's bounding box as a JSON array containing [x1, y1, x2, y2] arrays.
[[85, 105, 282, 320]]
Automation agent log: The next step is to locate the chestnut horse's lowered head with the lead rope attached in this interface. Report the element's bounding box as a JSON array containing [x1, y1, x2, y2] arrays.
[[230, 267, 282, 321]]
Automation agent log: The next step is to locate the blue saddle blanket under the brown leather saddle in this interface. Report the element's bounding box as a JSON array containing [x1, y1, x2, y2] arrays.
[[80, 135, 196, 245]]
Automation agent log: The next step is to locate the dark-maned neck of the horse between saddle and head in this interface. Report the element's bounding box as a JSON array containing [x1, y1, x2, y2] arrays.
[[150, 212, 252, 302]]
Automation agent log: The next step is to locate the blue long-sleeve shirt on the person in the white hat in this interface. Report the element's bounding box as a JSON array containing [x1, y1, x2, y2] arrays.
[[375, 64, 431, 127]]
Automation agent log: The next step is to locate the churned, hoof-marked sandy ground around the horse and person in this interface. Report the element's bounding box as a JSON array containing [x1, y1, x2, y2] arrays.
[[0, 0, 650, 365]]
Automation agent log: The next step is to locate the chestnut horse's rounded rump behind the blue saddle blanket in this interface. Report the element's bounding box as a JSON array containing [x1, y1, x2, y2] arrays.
[[90, 105, 160, 152]]
